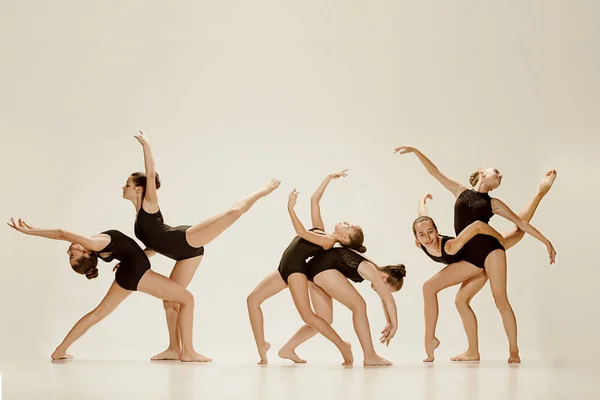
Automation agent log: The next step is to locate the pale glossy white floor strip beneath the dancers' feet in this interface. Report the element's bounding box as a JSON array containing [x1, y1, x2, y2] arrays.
[[0, 360, 600, 400]]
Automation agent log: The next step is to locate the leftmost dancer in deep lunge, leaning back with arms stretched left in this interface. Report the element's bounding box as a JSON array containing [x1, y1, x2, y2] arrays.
[[8, 218, 207, 362]]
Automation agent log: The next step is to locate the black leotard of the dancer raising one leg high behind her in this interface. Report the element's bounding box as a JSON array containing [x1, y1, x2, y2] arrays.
[[134, 207, 204, 261]]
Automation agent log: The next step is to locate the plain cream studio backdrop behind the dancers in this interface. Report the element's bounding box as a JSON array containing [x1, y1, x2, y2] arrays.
[[0, 1, 600, 378]]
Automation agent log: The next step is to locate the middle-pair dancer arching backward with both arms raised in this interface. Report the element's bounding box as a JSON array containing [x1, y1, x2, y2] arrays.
[[248, 170, 367, 366]]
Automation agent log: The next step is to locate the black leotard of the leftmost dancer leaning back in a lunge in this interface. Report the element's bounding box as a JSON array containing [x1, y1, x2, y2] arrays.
[[98, 230, 150, 291]]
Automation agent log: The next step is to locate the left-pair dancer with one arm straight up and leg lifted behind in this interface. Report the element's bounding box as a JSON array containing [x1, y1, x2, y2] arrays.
[[123, 131, 280, 361]]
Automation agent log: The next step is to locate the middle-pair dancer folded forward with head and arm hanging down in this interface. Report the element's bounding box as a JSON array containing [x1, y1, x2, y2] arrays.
[[278, 247, 406, 366]]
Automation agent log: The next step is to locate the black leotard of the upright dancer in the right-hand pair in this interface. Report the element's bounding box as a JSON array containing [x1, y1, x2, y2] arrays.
[[454, 189, 504, 268]]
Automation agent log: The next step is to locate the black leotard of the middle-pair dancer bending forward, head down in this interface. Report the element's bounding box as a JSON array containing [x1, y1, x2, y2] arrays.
[[306, 247, 366, 283]]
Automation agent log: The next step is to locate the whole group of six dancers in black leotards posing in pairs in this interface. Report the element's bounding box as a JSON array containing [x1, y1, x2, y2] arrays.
[[8, 131, 556, 366]]
